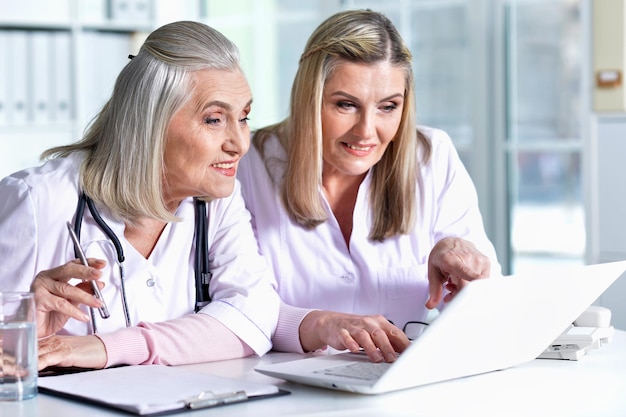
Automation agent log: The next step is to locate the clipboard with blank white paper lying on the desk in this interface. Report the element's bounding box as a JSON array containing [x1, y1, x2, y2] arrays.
[[38, 365, 289, 416]]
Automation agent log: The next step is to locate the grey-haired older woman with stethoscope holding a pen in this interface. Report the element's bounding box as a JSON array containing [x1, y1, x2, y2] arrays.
[[0, 22, 279, 368]]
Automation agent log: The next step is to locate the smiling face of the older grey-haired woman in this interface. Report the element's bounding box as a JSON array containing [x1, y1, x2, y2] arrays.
[[164, 70, 252, 206]]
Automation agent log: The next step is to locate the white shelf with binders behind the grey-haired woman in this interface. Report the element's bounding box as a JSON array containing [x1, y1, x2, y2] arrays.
[[0, 0, 156, 178]]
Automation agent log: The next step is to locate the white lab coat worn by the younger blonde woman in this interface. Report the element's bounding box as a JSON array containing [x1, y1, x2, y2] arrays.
[[238, 127, 500, 328]]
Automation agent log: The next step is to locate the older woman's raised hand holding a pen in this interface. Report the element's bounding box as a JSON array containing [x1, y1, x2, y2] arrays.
[[30, 258, 106, 338]]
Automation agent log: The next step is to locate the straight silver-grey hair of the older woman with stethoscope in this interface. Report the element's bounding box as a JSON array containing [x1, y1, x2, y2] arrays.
[[42, 21, 240, 223]]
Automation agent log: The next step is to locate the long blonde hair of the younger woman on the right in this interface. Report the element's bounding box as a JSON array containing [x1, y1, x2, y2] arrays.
[[254, 10, 430, 241]]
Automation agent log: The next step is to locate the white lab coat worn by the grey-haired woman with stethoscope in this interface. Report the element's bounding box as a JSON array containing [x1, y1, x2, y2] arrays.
[[0, 156, 279, 354]]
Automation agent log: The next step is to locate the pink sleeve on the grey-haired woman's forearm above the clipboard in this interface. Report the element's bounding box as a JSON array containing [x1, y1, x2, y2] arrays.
[[97, 313, 254, 367]]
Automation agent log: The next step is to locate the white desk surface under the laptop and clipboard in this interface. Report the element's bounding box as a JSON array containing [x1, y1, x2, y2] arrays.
[[0, 331, 626, 417]]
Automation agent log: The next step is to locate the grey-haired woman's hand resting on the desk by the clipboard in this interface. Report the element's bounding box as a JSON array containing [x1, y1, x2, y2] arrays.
[[38, 335, 107, 370]]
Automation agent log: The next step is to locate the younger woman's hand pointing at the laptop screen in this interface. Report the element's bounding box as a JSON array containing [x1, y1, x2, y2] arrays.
[[426, 238, 491, 309]]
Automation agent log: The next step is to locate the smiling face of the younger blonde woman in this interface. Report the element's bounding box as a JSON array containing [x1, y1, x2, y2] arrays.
[[322, 61, 405, 180]]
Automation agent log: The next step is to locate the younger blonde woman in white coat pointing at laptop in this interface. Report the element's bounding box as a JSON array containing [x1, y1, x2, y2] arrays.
[[239, 10, 500, 361]]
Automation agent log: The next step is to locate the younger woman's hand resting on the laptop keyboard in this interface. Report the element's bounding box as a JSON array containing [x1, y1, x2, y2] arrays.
[[300, 311, 410, 362]]
